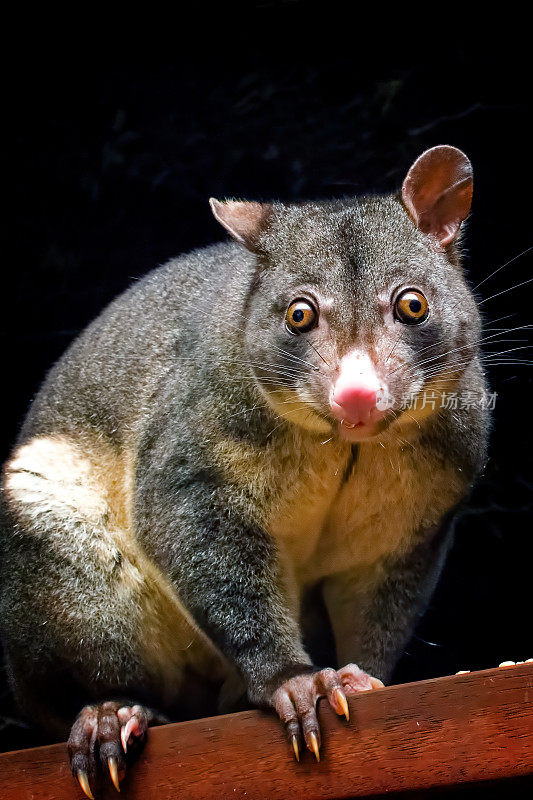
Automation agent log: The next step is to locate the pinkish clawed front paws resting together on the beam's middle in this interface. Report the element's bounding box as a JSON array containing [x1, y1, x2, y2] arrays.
[[272, 664, 383, 761]]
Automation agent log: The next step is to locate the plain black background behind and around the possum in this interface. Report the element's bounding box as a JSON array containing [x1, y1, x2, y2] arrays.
[[0, 2, 533, 780]]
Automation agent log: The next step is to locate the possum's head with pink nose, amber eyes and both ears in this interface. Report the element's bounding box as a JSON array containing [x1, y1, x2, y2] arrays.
[[211, 146, 480, 442]]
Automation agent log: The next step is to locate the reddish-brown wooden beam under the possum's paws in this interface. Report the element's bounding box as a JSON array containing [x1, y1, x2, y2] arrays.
[[0, 663, 533, 800]]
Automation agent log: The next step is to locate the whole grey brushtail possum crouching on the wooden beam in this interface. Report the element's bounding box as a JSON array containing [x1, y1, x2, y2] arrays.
[[0, 145, 488, 796]]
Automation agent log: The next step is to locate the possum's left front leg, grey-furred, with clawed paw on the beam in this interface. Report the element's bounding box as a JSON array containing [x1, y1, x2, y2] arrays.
[[135, 450, 380, 759]]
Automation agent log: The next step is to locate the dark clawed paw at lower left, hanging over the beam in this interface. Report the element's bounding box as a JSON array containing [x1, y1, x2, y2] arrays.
[[68, 700, 168, 800]]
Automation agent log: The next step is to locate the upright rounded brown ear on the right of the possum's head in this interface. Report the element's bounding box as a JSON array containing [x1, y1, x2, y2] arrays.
[[402, 144, 473, 247]]
